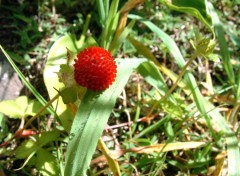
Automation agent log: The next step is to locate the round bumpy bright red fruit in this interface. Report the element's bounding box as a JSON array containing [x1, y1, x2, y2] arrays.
[[74, 46, 117, 91]]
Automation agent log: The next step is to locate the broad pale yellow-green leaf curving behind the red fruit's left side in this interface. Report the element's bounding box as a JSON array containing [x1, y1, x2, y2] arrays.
[[43, 35, 83, 131]]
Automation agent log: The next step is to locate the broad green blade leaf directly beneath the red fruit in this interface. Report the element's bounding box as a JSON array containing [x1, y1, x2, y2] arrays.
[[65, 59, 146, 176]]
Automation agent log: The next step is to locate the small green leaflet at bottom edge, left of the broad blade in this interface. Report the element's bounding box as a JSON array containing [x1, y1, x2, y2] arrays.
[[36, 148, 59, 175]]
